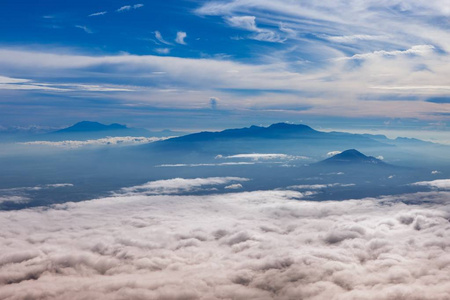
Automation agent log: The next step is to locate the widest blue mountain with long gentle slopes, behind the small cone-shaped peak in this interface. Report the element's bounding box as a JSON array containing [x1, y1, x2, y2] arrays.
[[148, 123, 393, 159]]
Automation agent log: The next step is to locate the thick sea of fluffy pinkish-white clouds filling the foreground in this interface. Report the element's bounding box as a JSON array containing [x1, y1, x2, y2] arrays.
[[0, 177, 450, 300]]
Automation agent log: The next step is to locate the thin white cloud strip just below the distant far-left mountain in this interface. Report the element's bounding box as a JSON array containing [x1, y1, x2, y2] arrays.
[[22, 136, 170, 148]]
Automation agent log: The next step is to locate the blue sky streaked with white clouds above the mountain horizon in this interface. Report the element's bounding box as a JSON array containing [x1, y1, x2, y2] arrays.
[[0, 0, 450, 131]]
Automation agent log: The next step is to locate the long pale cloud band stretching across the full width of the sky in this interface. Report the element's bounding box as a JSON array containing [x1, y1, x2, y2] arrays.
[[0, 45, 450, 119]]
